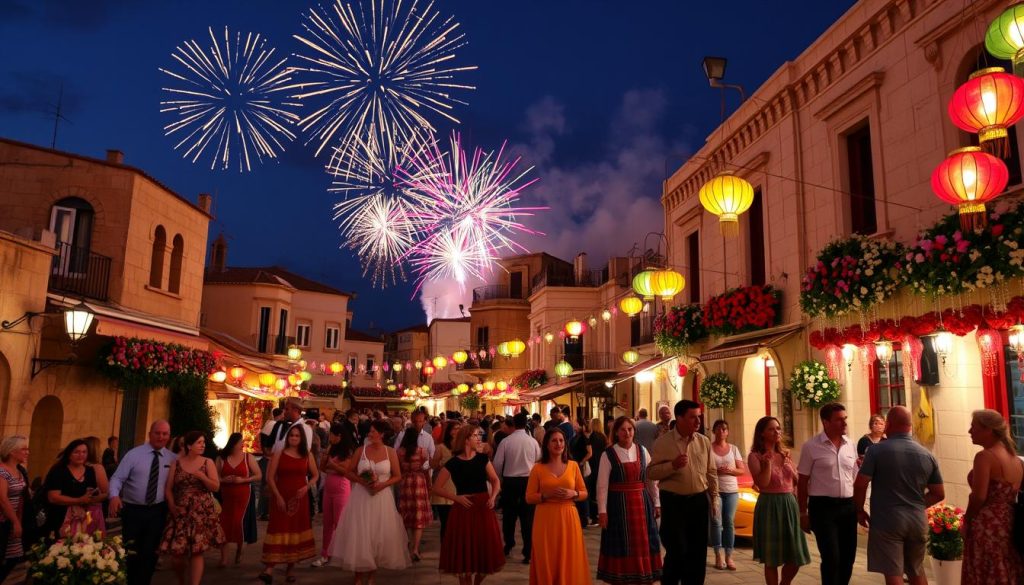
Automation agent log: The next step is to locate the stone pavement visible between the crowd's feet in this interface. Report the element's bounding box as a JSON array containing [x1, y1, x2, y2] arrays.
[[154, 518, 927, 585]]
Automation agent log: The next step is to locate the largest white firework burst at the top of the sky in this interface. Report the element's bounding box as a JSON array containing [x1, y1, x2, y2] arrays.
[[293, 0, 476, 165]]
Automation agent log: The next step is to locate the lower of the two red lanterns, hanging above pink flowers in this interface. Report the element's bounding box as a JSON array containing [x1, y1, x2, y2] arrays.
[[932, 147, 1010, 232]]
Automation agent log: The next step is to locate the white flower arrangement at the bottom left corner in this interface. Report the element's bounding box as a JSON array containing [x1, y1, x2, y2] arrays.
[[29, 532, 127, 585]]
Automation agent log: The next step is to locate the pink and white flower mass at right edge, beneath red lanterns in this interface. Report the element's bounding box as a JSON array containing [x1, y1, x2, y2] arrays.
[[903, 206, 1024, 297]]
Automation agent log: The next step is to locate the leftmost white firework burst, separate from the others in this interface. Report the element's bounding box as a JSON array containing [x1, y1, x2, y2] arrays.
[[160, 27, 299, 171]]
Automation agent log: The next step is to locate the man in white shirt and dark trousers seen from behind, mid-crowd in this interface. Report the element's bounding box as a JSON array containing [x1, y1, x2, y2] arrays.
[[494, 412, 541, 565]]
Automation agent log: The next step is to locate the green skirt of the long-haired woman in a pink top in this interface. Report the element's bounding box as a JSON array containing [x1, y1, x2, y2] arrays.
[[754, 494, 811, 567]]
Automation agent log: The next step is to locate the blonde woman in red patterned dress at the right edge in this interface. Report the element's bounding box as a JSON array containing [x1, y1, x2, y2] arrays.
[[962, 410, 1024, 585]]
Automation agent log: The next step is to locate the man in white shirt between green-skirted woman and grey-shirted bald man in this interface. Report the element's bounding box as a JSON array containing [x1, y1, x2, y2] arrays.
[[797, 403, 857, 585]]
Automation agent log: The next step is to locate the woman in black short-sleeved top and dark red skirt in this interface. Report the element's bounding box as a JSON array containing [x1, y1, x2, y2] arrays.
[[434, 425, 505, 585]]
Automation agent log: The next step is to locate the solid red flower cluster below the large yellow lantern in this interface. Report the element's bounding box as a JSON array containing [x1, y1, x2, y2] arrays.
[[703, 285, 782, 336]]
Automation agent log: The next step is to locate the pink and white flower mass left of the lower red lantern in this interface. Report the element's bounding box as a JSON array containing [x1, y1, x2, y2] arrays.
[[800, 235, 904, 318]]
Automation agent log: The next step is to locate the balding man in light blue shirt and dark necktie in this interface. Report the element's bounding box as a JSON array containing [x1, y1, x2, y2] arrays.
[[110, 420, 175, 585]]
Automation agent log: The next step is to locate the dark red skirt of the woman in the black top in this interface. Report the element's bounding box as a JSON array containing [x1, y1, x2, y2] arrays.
[[438, 493, 505, 575]]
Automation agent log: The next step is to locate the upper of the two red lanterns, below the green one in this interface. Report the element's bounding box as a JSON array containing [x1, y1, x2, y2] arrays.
[[949, 67, 1024, 159]]
